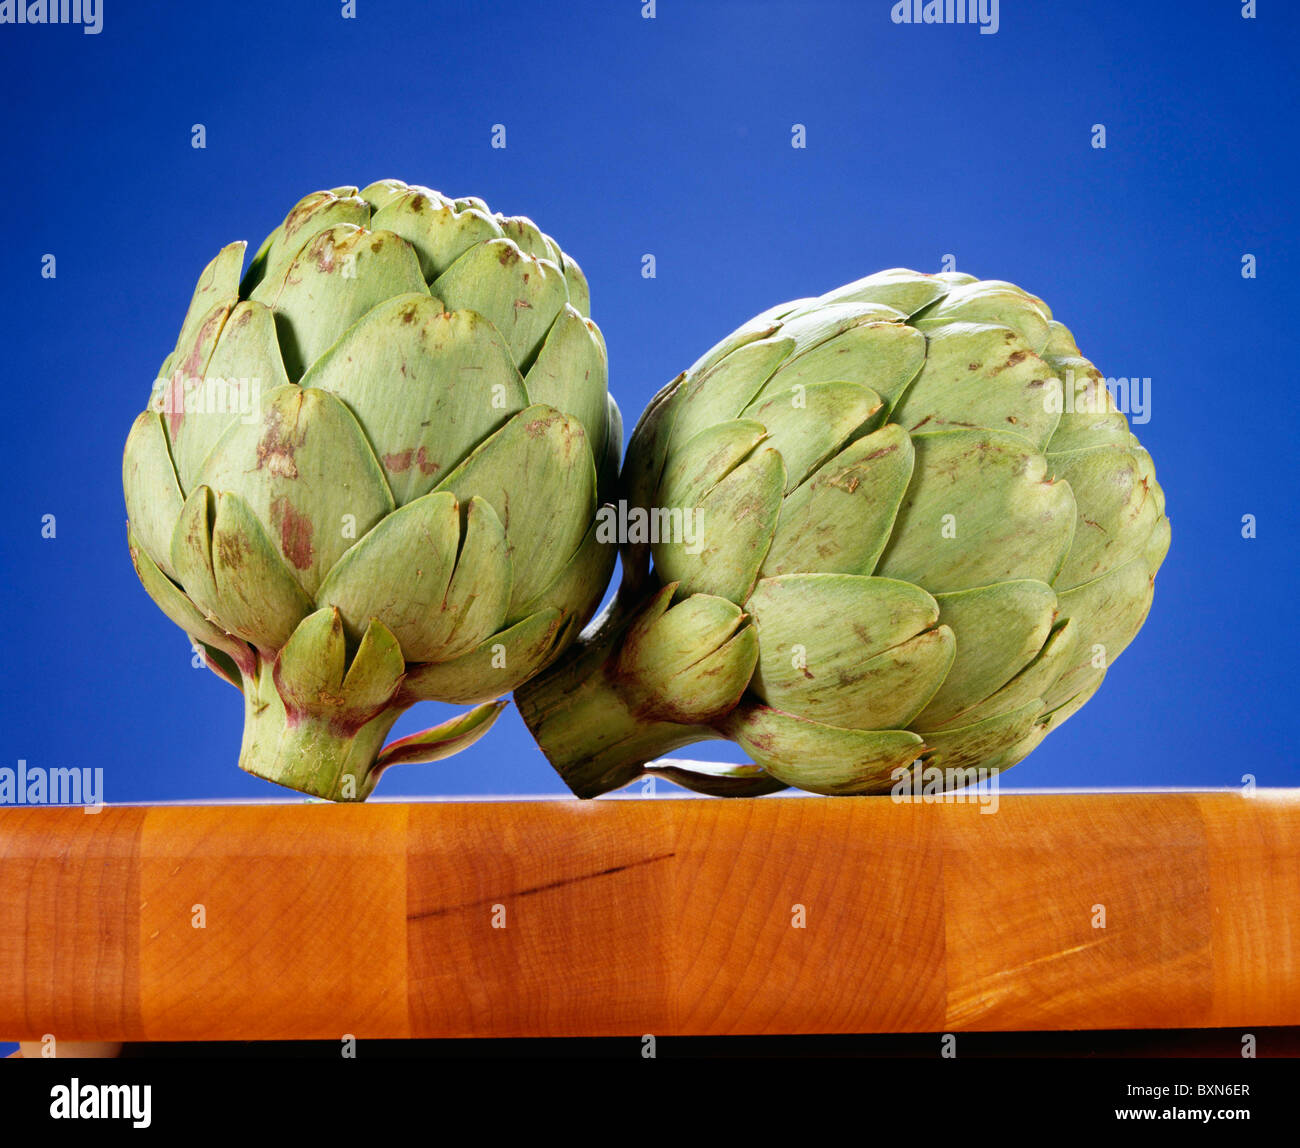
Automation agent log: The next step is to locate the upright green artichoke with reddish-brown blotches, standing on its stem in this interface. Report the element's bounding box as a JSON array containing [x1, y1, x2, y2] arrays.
[[122, 179, 623, 801]]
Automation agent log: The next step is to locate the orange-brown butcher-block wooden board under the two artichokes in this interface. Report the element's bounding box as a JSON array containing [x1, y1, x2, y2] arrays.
[[0, 790, 1300, 1040]]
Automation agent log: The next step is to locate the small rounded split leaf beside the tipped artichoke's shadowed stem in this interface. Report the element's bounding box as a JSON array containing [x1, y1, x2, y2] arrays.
[[614, 584, 758, 724]]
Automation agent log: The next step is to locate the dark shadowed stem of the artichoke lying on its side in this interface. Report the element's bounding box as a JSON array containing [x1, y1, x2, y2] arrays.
[[515, 592, 722, 797]]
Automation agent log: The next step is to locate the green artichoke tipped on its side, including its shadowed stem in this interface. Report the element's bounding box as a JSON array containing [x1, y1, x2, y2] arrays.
[[516, 269, 1170, 797]]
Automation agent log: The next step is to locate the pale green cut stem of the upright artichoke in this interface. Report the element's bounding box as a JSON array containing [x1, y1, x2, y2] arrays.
[[239, 663, 402, 801]]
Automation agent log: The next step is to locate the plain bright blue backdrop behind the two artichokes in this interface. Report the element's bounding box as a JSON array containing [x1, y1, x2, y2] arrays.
[[0, 0, 1300, 816]]
